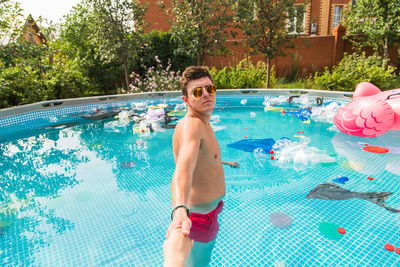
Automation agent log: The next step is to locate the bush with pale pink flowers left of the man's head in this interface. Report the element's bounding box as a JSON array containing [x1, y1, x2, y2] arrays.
[[129, 56, 180, 93]]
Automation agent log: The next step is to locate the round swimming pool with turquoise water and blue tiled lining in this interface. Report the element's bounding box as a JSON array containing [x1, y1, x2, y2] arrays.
[[0, 90, 400, 266]]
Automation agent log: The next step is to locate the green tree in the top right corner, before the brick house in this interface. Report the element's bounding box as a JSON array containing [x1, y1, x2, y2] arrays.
[[344, 0, 400, 59]]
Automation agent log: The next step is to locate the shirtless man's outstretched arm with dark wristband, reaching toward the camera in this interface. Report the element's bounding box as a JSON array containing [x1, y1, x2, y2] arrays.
[[167, 119, 204, 236]]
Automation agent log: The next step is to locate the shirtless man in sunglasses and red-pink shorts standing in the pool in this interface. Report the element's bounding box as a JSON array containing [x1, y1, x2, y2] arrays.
[[167, 66, 239, 266]]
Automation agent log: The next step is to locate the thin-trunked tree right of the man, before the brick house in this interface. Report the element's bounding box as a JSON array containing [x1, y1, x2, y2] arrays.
[[233, 0, 305, 88]]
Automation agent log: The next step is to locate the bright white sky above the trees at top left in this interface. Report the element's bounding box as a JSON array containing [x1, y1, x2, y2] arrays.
[[18, 0, 81, 23]]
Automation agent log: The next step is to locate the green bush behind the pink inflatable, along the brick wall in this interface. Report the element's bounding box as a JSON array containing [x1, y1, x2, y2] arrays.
[[314, 53, 396, 91]]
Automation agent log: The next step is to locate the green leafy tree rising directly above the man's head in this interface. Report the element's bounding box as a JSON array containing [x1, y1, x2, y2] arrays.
[[159, 0, 235, 65]]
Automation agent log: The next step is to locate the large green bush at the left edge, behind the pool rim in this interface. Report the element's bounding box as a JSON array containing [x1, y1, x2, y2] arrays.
[[0, 44, 89, 108]]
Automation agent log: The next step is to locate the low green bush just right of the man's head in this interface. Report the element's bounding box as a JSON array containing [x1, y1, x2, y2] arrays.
[[210, 58, 276, 89]]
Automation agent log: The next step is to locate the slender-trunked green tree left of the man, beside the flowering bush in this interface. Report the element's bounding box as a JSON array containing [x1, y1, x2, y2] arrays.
[[89, 0, 146, 89]]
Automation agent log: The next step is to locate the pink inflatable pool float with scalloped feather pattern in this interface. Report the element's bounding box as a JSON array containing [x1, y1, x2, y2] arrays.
[[333, 82, 400, 137]]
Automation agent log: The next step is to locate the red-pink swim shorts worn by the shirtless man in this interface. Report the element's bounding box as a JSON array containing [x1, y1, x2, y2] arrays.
[[189, 200, 224, 243]]
